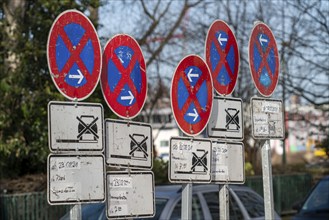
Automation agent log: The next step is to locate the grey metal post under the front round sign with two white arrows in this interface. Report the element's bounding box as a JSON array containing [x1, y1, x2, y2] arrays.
[[181, 183, 192, 220]]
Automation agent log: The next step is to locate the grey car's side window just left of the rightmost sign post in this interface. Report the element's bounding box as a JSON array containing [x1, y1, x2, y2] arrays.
[[235, 190, 265, 218]]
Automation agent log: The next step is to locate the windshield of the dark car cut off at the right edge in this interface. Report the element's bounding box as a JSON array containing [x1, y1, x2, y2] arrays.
[[302, 179, 329, 212]]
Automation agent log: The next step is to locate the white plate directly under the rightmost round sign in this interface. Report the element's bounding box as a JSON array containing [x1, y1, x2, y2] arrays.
[[251, 97, 284, 139]]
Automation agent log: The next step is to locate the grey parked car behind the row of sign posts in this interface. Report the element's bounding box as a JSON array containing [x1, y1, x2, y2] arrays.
[[61, 185, 280, 220]]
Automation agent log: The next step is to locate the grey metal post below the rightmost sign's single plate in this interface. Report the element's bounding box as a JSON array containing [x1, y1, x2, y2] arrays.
[[262, 140, 274, 219]]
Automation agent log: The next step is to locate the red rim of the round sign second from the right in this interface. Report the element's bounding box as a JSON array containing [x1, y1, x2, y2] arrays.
[[205, 20, 240, 95]]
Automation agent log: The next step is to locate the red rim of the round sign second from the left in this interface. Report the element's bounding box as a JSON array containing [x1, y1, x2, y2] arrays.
[[101, 34, 148, 119]]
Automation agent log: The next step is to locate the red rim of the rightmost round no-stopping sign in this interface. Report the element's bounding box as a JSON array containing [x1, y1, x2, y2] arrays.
[[248, 22, 280, 97]]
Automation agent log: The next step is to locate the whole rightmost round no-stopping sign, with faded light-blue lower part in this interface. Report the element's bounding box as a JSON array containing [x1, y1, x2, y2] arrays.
[[249, 22, 280, 97]]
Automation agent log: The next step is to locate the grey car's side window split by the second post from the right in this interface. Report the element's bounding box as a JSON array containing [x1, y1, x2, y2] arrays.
[[203, 192, 243, 220]]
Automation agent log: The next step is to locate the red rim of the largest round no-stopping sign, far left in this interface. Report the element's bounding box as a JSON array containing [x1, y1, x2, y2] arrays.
[[47, 10, 102, 101]]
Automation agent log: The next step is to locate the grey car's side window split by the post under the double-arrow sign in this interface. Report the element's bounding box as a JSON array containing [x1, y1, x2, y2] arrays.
[[170, 195, 204, 220]]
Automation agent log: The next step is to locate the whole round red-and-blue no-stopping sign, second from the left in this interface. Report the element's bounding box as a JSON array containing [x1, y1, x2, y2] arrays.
[[101, 34, 147, 119]]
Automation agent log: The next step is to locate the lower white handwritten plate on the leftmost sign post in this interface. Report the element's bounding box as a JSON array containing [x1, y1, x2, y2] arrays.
[[47, 154, 105, 205]]
